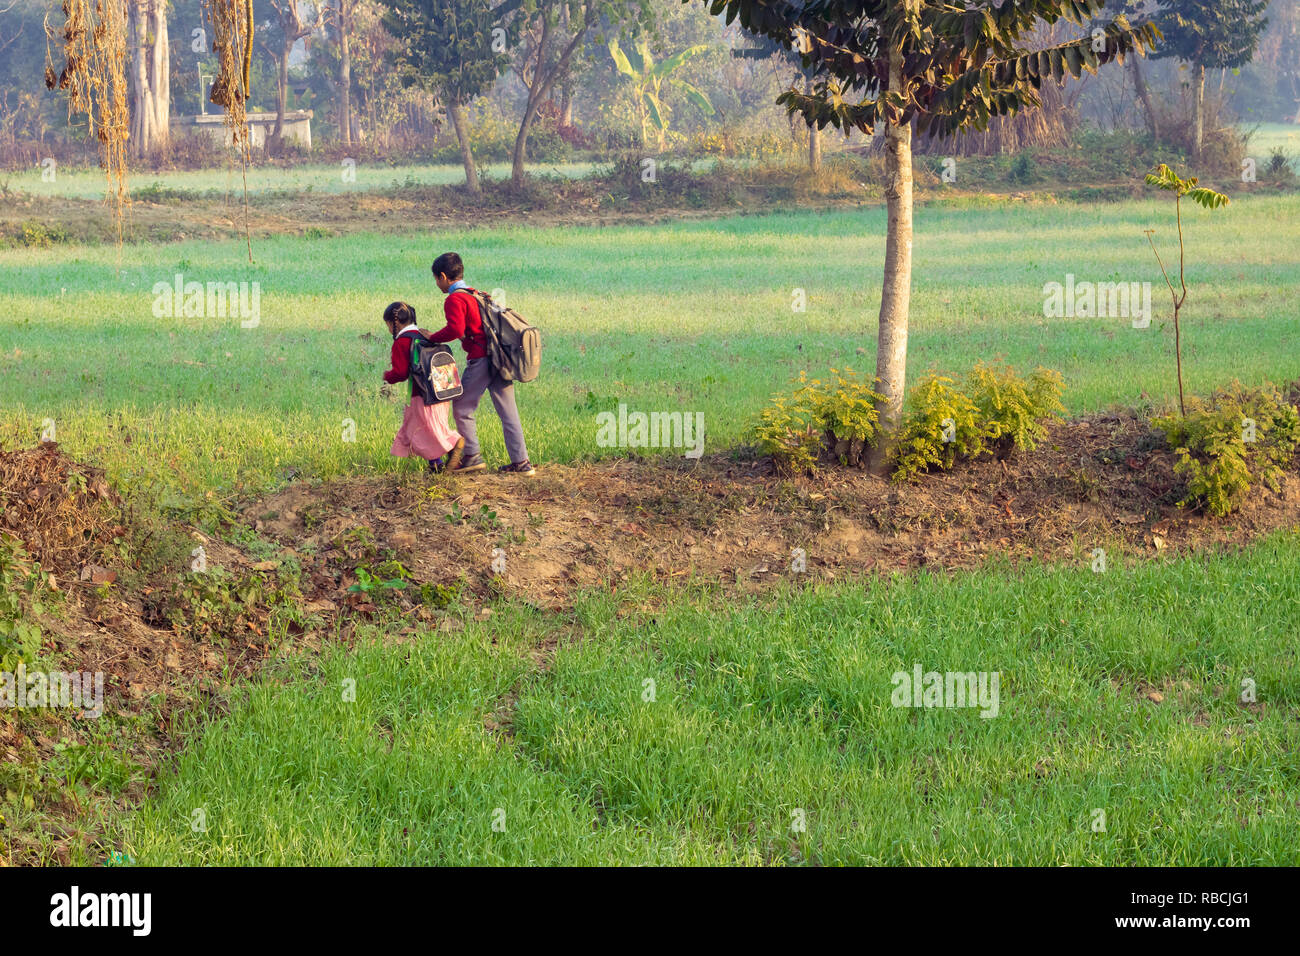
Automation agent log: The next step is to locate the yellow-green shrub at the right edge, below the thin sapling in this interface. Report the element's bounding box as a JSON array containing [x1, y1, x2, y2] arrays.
[[1152, 382, 1300, 516]]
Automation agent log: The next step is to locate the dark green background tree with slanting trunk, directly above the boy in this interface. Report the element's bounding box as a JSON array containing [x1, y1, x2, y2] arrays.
[[382, 0, 510, 193]]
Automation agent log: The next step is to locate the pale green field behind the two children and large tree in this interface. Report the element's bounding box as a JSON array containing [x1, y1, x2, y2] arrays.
[[0, 196, 1300, 509]]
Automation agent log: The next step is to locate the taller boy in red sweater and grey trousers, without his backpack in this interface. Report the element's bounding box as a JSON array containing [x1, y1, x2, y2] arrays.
[[429, 252, 537, 475]]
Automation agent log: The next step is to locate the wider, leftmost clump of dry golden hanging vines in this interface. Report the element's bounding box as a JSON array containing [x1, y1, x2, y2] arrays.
[[46, 0, 130, 242]]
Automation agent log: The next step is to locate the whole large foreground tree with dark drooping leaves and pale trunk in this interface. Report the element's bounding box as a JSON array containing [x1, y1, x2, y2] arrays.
[[705, 0, 1157, 473]]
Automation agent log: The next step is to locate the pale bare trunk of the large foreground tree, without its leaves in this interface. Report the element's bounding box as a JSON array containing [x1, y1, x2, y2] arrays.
[[868, 51, 913, 475]]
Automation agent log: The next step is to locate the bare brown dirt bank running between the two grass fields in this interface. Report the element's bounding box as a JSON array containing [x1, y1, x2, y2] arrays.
[[244, 415, 1300, 611]]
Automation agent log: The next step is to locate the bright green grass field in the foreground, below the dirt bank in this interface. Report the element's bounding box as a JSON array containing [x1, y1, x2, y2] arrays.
[[121, 533, 1300, 865]]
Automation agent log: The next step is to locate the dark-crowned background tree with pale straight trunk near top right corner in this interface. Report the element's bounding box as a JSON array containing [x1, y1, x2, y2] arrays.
[[1156, 0, 1269, 160]]
